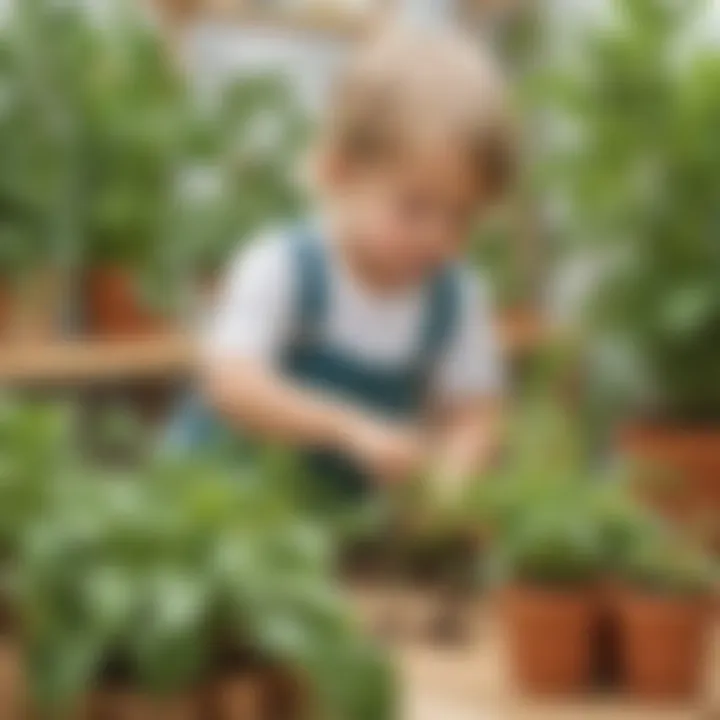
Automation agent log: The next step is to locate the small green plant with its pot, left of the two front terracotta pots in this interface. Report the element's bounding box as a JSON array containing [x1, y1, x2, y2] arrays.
[[494, 496, 601, 694]]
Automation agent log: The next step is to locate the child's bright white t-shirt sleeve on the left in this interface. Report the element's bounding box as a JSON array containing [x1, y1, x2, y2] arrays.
[[203, 235, 294, 364]]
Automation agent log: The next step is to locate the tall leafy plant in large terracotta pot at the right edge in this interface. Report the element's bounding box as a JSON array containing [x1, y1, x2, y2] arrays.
[[544, 0, 720, 536]]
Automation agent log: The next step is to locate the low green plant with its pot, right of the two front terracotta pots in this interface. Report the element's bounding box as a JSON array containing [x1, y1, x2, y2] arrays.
[[615, 534, 718, 700]]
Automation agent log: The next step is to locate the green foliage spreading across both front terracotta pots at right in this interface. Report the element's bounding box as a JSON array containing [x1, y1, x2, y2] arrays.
[[466, 402, 717, 593]]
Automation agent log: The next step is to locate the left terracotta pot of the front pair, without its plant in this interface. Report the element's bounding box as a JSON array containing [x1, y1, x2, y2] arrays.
[[502, 587, 599, 695]]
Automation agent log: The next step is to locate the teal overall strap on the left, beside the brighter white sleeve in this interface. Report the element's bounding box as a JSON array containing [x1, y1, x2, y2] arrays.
[[288, 225, 329, 340]]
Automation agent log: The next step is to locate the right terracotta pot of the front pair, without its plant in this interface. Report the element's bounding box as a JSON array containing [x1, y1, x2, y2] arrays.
[[618, 590, 712, 700]]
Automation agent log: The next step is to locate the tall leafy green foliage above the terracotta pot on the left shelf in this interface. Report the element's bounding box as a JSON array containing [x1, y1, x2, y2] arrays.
[[8, 0, 188, 272]]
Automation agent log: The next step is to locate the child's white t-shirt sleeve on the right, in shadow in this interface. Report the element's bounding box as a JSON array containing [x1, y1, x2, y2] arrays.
[[434, 273, 505, 403]]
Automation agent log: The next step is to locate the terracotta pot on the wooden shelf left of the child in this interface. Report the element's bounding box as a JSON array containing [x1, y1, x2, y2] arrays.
[[86, 265, 167, 337]]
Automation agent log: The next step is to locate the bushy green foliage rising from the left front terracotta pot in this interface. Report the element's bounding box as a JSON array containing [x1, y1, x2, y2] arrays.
[[465, 393, 648, 586]]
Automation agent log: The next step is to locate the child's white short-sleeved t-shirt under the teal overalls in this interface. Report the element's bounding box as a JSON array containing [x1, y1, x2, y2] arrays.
[[205, 233, 503, 402]]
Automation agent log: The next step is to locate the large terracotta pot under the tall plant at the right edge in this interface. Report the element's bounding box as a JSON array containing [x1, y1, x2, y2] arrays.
[[620, 425, 720, 544]]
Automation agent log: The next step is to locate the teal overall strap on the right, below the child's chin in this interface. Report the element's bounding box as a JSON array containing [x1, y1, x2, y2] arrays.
[[419, 266, 462, 373]]
